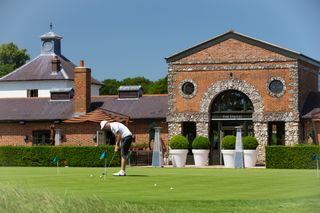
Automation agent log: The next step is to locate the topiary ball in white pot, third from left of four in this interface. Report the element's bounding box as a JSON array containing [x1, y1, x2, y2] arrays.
[[221, 135, 236, 168]]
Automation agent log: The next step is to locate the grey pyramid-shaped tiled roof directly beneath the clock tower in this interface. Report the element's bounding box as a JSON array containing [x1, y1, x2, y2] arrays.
[[0, 54, 101, 85]]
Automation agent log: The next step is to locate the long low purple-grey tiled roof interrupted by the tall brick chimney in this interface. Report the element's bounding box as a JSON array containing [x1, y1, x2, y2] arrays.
[[0, 95, 168, 121]]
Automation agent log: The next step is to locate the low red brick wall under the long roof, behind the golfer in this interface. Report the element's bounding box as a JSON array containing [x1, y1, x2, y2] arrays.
[[0, 120, 168, 146]]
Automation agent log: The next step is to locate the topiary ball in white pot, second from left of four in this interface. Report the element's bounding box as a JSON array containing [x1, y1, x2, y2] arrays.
[[192, 136, 210, 166]]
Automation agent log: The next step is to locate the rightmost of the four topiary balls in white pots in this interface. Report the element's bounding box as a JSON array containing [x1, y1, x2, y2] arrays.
[[243, 136, 259, 168]]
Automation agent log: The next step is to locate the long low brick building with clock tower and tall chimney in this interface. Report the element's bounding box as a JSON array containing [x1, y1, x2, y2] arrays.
[[0, 32, 168, 146]]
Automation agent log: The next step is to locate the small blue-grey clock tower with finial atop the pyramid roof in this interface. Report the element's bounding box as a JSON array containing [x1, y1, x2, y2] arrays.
[[40, 24, 62, 55]]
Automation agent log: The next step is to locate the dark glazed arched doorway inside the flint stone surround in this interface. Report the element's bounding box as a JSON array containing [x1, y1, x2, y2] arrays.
[[209, 90, 253, 165]]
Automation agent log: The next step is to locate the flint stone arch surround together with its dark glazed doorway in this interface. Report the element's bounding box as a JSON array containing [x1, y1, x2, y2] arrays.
[[197, 79, 268, 164]]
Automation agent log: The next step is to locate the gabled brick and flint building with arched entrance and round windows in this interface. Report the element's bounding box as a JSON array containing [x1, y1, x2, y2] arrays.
[[166, 31, 320, 163]]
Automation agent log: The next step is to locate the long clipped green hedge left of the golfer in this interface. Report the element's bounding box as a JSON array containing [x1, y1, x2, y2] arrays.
[[0, 146, 120, 167]]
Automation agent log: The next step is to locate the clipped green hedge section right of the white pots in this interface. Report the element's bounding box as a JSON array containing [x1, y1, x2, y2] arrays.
[[266, 145, 320, 169]]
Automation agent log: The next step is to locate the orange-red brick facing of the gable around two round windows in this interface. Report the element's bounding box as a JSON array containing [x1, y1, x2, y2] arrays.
[[172, 39, 296, 112]]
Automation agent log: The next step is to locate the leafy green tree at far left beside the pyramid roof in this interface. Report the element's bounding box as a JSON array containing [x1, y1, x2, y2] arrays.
[[0, 42, 30, 77]]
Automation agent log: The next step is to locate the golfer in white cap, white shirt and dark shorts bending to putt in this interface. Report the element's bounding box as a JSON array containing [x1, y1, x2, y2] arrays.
[[100, 121, 132, 176]]
